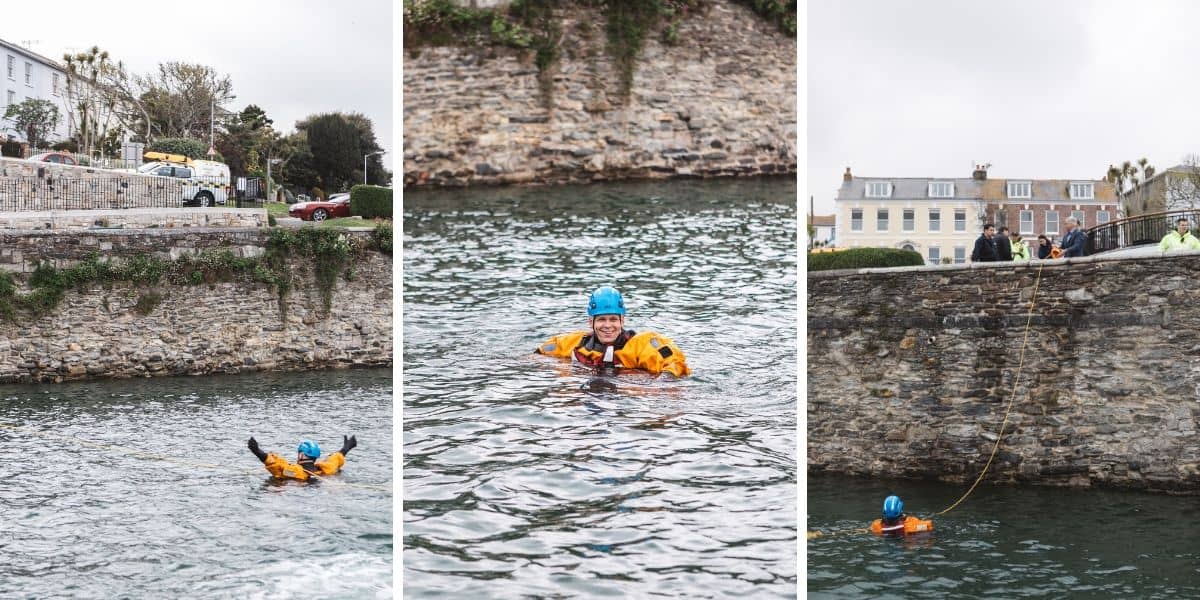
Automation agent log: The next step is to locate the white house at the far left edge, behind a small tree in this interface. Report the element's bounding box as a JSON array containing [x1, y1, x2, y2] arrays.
[[0, 40, 68, 142]]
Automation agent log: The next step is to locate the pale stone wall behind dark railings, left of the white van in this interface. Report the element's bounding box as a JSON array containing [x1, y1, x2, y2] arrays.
[[0, 158, 225, 212]]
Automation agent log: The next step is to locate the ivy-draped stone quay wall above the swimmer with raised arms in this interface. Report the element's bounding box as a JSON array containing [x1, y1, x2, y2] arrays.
[[0, 229, 392, 383]]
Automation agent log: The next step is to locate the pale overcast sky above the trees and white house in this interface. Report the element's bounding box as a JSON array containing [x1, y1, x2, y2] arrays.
[[0, 0, 398, 169]]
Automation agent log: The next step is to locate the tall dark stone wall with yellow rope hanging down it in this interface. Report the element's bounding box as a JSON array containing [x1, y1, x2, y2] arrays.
[[808, 253, 1200, 493]]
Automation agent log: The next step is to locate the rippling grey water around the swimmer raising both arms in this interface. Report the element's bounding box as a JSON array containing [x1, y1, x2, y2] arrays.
[[0, 370, 392, 599]]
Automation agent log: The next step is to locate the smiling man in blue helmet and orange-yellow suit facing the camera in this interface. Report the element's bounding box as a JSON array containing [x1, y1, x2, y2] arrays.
[[535, 286, 691, 377]]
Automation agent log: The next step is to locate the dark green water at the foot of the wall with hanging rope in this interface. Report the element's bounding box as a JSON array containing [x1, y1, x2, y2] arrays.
[[806, 476, 1200, 599]]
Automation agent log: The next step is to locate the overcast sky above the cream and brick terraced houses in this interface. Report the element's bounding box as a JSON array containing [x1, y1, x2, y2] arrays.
[[802, 0, 1200, 215]]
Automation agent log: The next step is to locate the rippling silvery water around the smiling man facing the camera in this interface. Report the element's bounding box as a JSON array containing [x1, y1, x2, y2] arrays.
[[403, 180, 797, 599]]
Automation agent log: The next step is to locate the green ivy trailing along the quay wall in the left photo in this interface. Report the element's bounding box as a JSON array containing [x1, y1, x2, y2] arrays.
[[0, 227, 379, 322]]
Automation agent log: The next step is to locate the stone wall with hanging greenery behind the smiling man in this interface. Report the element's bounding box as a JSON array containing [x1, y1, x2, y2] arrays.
[[403, 0, 797, 186]]
